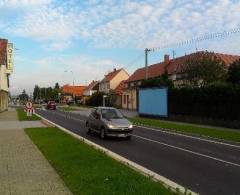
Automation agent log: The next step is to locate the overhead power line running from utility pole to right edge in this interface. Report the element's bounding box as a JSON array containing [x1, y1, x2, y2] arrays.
[[148, 27, 240, 51]]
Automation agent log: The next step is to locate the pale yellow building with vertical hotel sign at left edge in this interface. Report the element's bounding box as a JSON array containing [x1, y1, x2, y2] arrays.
[[0, 39, 13, 112]]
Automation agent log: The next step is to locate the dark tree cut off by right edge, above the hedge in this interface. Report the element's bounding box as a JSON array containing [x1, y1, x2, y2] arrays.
[[227, 59, 240, 85]]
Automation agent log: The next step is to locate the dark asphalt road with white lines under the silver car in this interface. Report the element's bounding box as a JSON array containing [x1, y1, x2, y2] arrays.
[[37, 110, 240, 195]]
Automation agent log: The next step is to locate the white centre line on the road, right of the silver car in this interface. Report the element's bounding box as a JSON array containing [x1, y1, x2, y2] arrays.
[[132, 134, 240, 167]]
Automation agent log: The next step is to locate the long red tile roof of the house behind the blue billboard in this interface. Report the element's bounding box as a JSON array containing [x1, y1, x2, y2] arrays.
[[127, 51, 240, 82]]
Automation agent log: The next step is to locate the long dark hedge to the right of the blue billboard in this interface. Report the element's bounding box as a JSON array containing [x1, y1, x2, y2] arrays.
[[169, 85, 240, 120]]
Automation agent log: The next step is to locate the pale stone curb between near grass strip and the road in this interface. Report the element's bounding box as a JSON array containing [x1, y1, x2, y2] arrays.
[[36, 113, 198, 195]]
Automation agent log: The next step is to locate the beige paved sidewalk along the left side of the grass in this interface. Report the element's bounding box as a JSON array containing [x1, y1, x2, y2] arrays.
[[0, 110, 71, 195]]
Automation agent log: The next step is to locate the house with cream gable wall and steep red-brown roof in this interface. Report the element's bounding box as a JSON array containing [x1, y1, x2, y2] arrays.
[[99, 68, 129, 93]]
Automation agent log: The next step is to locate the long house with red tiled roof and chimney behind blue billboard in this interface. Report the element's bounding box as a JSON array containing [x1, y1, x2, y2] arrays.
[[122, 51, 240, 110]]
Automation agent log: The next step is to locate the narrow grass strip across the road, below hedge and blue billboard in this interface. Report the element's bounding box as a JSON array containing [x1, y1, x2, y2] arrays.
[[129, 117, 240, 142]]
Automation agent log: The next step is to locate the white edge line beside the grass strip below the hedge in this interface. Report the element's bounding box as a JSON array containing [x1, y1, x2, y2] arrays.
[[134, 125, 240, 148]]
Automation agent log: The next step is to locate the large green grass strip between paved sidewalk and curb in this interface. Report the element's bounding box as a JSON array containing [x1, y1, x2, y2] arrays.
[[25, 127, 177, 195]]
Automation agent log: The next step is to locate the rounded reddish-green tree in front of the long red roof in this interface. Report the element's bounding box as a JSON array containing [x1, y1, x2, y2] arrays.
[[182, 51, 227, 87]]
